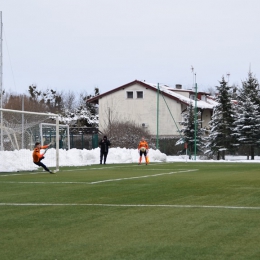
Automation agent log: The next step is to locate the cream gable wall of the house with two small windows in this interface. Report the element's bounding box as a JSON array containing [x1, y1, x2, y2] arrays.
[[99, 84, 182, 136]]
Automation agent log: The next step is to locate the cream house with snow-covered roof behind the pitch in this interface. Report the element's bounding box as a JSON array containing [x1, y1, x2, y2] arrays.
[[87, 80, 216, 137]]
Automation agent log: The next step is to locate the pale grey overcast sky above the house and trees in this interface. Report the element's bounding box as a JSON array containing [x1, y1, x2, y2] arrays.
[[0, 0, 260, 94]]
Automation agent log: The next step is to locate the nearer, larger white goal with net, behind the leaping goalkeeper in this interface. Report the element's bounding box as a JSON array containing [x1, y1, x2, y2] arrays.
[[0, 108, 60, 172]]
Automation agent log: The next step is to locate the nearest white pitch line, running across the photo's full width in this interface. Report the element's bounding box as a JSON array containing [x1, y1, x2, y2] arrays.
[[0, 203, 260, 210]]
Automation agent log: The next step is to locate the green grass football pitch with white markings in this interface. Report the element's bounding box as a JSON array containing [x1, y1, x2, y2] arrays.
[[0, 162, 260, 260]]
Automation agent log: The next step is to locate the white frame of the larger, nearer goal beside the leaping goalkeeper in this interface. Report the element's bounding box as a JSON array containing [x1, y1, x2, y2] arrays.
[[0, 108, 59, 171]]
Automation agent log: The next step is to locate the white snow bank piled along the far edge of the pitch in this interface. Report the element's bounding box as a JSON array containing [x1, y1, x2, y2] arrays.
[[0, 148, 260, 172]]
